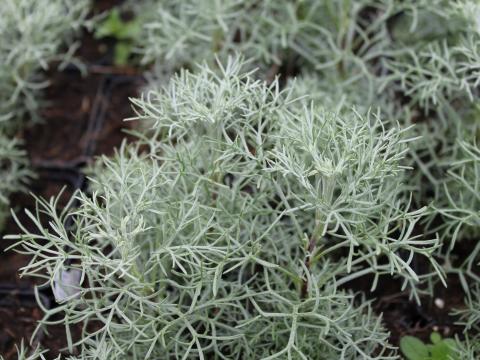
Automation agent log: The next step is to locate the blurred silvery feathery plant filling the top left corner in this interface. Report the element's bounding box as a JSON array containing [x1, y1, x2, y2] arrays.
[[0, 0, 89, 127]]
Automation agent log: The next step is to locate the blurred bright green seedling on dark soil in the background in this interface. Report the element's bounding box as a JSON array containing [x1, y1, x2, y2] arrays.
[[95, 8, 141, 65]]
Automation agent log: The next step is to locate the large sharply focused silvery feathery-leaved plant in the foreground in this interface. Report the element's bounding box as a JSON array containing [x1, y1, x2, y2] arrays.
[[8, 57, 442, 360]]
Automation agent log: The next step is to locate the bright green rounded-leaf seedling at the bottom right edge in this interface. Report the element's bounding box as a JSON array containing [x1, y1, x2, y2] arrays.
[[400, 332, 459, 360]]
